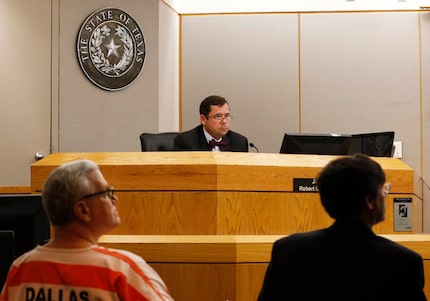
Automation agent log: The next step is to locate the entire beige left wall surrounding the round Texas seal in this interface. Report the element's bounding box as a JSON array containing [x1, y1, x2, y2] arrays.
[[0, 0, 180, 185]]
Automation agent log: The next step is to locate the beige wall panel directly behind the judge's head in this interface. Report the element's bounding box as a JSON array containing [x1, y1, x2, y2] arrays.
[[182, 14, 298, 152]]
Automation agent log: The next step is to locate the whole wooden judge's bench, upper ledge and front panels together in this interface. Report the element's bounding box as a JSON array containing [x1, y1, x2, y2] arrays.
[[32, 152, 422, 235]]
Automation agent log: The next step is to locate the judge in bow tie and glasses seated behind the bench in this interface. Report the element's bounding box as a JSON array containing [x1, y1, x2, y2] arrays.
[[174, 95, 249, 152]]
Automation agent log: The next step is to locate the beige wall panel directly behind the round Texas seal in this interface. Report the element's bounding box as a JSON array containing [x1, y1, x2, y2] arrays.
[[58, 0, 163, 152]]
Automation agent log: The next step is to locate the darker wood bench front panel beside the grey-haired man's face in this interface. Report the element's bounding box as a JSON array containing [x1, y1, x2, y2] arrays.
[[110, 191, 217, 235]]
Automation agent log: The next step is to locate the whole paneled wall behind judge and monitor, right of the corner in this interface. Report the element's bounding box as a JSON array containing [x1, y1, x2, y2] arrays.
[[181, 12, 430, 230]]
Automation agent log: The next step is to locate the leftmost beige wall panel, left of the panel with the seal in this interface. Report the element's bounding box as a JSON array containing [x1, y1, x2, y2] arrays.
[[0, 0, 52, 186]]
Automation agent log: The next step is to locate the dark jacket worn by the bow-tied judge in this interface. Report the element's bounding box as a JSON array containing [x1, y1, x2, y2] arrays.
[[174, 125, 249, 152]]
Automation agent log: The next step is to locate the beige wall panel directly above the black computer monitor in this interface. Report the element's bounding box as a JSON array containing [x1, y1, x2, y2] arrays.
[[300, 13, 421, 166]]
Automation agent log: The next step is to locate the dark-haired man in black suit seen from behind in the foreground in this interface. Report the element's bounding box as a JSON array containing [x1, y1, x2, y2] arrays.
[[258, 154, 426, 301]]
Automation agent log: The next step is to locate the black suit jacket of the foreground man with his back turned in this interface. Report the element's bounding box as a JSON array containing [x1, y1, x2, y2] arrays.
[[258, 221, 426, 301]]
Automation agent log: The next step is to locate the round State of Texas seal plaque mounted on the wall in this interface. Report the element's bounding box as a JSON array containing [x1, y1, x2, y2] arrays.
[[77, 8, 146, 91]]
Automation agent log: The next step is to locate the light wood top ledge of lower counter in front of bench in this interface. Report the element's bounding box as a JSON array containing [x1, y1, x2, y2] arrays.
[[99, 234, 430, 263]]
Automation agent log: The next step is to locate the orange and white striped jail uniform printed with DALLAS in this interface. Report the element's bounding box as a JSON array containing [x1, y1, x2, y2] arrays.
[[0, 246, 173, 301]]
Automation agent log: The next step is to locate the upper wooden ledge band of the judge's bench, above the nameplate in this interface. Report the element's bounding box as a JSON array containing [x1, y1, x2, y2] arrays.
[[31, 152, 414, 194]]
